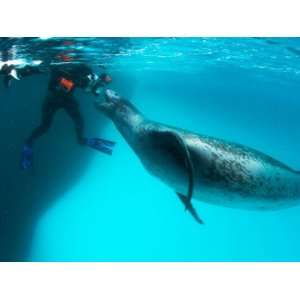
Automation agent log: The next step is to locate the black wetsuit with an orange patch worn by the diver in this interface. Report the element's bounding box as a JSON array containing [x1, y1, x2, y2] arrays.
[[26, 64, 99, 146]]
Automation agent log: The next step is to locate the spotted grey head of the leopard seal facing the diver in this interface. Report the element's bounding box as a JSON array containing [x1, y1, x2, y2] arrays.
[[96, 89, 140, 121]]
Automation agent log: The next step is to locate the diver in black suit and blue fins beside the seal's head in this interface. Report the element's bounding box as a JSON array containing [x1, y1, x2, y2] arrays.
[[21, 64, 115, 169]]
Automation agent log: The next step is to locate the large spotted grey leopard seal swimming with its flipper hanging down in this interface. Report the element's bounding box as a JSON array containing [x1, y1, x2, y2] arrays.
[[95, 90, 300, 223]]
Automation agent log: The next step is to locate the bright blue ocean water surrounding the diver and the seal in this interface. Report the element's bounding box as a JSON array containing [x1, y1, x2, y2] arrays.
[[0, 38, 300, 261]]
